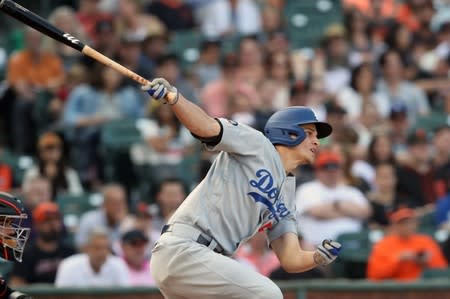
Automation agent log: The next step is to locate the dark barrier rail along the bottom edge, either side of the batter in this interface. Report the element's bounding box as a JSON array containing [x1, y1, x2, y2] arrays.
[[15, 279, 450, 299]]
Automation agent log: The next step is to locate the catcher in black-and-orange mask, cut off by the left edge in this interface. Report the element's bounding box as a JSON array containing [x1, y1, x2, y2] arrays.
[[0, 192, 32, 299]]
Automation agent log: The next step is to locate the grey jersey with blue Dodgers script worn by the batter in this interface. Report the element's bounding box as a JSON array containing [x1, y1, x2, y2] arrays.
[[169, 118, 297, 254]]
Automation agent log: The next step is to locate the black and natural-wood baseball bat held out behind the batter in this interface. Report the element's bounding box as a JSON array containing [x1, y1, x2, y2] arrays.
[[0, 0, 174, 101]]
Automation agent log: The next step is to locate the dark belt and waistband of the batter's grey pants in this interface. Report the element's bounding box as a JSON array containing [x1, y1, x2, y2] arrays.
[[161, 223, 225, 255]]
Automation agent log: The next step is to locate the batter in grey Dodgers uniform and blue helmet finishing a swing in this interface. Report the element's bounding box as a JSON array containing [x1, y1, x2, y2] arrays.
[[142, 78, 341, 299]]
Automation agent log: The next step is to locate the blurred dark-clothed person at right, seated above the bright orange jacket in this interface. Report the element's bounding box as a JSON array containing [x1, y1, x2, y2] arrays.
[[397, 129, 437, 212]]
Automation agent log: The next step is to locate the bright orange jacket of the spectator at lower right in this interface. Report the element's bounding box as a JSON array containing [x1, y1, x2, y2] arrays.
[[367, 234, 448, 281]]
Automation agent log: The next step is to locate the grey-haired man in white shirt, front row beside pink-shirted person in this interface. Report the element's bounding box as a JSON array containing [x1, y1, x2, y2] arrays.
[[55, 226, 130, 288]]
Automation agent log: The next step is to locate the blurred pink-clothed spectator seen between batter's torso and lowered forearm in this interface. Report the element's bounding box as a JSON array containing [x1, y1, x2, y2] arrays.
[[235, 232, 280, 277]]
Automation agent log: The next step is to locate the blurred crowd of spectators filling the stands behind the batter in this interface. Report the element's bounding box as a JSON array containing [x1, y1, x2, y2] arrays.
[[0, 0, 450, 287]]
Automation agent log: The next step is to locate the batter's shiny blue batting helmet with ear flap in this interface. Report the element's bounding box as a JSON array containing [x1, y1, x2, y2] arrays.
[[264, 106, 332, 146]]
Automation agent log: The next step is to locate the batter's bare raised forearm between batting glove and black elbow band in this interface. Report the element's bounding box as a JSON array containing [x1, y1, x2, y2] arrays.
[[171, 93, 220, 137]]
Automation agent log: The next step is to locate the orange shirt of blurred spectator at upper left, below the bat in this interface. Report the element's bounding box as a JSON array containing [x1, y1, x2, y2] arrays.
[[7, 50, 64, 87]]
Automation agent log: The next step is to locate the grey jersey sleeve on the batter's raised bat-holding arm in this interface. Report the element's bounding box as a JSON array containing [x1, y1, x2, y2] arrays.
[[205, 118, 269, 155]]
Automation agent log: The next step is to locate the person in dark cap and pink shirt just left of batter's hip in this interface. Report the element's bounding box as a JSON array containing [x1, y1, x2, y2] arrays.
[[121, 229, 155, 286]]
